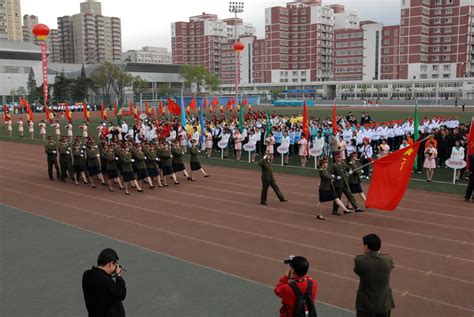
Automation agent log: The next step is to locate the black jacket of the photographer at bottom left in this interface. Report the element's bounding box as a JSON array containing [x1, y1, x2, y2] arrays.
[[82, 267, 127, 317]]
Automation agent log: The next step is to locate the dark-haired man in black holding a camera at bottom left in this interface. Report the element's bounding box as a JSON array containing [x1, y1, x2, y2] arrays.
[[82, 249, 127, 317]]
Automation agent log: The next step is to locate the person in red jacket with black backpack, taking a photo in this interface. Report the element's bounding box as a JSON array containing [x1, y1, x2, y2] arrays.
[[274, 256, 318, 317]]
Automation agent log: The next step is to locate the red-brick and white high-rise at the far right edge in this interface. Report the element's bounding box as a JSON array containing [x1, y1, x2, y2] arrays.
[[398, 0, 474, 80]]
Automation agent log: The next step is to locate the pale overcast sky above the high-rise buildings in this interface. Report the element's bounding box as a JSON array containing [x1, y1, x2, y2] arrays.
[[21, 0, 400, 51]]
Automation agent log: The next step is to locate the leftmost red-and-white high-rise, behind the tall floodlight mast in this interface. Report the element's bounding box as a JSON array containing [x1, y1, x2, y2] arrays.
[[171, 13, 255, 83]]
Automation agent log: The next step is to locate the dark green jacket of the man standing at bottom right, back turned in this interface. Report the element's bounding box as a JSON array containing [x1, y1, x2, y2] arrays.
[[354, 251, 395, 313]]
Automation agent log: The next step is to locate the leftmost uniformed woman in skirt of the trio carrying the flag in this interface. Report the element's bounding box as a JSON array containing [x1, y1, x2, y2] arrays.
[[316, 157, 349, 220]]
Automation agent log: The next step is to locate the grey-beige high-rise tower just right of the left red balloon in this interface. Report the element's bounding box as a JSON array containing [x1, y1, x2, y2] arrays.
[[58, 0, 122, 64]]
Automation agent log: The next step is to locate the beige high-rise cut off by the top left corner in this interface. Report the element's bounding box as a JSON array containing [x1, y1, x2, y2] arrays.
[[0, 0, 23, 41]]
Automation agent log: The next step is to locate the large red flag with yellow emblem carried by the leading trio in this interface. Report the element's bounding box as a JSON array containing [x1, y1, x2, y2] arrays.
[[365, 141, 421, 211]]
